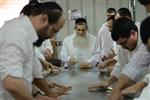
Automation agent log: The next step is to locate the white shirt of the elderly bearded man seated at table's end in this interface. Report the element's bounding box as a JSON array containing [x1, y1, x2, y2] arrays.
[[60, 33, 96, 63]]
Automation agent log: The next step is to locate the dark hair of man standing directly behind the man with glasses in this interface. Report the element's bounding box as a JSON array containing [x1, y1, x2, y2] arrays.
[[117, 8, 132, 19]]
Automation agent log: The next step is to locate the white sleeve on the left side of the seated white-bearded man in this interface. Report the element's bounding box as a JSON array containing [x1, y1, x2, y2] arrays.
[[60, 40, 71, 63]]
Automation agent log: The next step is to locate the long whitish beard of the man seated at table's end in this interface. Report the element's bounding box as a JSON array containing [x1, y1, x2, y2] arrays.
[[73, 35, 90, 49]]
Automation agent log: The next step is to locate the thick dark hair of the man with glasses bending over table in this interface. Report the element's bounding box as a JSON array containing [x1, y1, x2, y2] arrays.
[[111, 17, 138, 41]]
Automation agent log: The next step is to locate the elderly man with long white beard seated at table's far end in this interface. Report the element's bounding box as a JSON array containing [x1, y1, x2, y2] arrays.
[[60, 18, 96, 67]]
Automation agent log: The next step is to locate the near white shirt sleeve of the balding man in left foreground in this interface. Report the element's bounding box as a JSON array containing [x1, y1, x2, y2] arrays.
[[0, 32, 27, 80]]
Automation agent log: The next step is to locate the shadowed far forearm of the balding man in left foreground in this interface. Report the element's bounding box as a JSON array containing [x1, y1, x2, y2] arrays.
[[33, 78, 51, 96]]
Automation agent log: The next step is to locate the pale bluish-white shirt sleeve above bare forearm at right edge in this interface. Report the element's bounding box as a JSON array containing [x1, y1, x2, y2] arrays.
[[122, 44, 150, 82]]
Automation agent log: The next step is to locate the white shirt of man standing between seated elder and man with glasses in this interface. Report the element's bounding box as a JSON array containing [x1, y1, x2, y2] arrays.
[[88, 22, 116, 65]]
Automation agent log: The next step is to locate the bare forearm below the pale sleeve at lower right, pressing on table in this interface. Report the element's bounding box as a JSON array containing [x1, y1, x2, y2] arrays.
[[110, 74, 134, 100]]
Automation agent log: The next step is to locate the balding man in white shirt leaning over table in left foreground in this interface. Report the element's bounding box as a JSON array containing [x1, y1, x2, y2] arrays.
[[0, 2, 65, 100]]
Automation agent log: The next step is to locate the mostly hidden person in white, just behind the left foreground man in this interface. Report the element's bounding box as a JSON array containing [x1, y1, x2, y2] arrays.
[[34, 39, 60, 76]]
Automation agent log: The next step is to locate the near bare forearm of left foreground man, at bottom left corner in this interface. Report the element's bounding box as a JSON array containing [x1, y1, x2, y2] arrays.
[[3, 76, 34, 100]]
